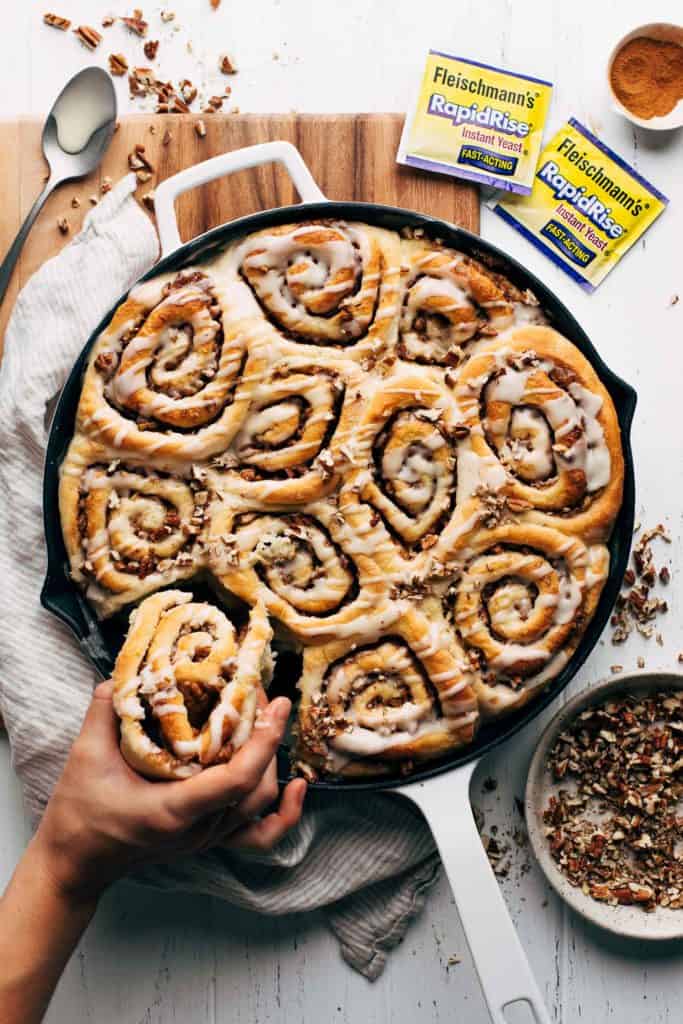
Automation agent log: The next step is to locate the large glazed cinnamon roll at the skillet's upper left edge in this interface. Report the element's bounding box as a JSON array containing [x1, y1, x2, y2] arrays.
[[78, 269, 255, 463]]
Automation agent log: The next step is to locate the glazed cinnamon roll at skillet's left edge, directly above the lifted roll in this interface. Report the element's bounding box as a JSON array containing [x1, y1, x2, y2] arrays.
[[59, 438, 209, 615]]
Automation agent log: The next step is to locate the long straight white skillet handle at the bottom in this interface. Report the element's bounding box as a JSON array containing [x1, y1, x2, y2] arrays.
[[397, 763, 551, 1024]]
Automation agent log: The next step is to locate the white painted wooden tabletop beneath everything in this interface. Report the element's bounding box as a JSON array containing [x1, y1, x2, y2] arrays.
[[0, 0, 683, 1024]]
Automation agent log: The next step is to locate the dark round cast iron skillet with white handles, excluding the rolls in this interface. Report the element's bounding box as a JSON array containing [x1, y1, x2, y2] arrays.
[[41, 142, 636, 1024]]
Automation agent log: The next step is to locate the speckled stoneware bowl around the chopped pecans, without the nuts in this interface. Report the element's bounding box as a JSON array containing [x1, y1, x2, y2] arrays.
[[524, 672, 683, 941]]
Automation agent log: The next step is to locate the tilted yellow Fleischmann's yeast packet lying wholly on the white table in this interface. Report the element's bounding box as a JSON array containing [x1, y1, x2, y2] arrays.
[[494, 118, 669, 292]]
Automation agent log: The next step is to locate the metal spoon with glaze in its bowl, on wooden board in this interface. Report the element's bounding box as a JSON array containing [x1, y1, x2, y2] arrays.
[[0, 68, 117, 302]]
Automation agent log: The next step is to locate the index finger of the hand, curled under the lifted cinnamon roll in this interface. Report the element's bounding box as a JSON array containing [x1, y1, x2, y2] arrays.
[[164, 697, 292, 824]]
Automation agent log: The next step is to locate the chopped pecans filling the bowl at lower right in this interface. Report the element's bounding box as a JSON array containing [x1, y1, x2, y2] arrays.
[[543, 691, 683, 910]]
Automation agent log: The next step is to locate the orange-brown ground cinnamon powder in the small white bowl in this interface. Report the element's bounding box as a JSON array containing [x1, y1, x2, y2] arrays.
[[609, 36, 683, 121]]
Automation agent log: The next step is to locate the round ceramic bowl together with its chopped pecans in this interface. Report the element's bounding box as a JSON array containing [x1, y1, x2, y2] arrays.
[[524, 672, 683, 940]]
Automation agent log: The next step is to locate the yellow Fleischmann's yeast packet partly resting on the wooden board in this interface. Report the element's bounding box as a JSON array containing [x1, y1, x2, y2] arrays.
[[396, 50, 553, 196]]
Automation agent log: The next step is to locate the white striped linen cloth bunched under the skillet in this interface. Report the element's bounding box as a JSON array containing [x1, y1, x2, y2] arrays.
[[0, 175, 439, 979]]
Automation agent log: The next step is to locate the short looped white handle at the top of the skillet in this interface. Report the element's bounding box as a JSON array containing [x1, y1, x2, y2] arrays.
[[155, 140, 326, 256]]
